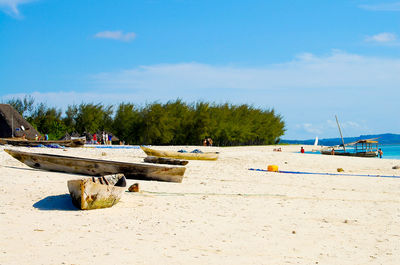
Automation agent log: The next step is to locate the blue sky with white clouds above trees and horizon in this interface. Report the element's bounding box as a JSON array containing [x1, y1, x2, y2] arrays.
[[0, 0, 400, 139]]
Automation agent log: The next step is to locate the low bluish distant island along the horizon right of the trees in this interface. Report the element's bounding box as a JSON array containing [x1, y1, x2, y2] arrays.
[[280, 133, 400, 146]]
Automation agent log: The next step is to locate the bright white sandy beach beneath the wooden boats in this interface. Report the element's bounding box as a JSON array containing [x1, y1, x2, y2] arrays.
[[0, 146, 400, 265]]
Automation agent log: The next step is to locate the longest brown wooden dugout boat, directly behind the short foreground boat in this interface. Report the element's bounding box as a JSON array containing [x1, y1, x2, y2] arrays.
[[4, 149, 186, 182]]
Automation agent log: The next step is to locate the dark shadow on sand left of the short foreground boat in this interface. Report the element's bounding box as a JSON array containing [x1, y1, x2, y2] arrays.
[[33, 194, 79, 211]]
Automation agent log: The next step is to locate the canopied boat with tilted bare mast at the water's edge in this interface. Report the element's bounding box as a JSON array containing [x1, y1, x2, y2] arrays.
[[321, 115, 378, 157]]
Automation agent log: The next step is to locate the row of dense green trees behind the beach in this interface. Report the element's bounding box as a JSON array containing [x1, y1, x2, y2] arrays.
[[6, 96, 285, 146]]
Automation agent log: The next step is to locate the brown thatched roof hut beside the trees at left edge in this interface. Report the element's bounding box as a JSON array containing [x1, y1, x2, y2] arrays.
[[0, 104, 39, 139]]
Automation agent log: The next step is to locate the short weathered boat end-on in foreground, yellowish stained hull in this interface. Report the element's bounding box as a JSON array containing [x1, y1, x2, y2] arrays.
[[67, 174, 126, 210]]
